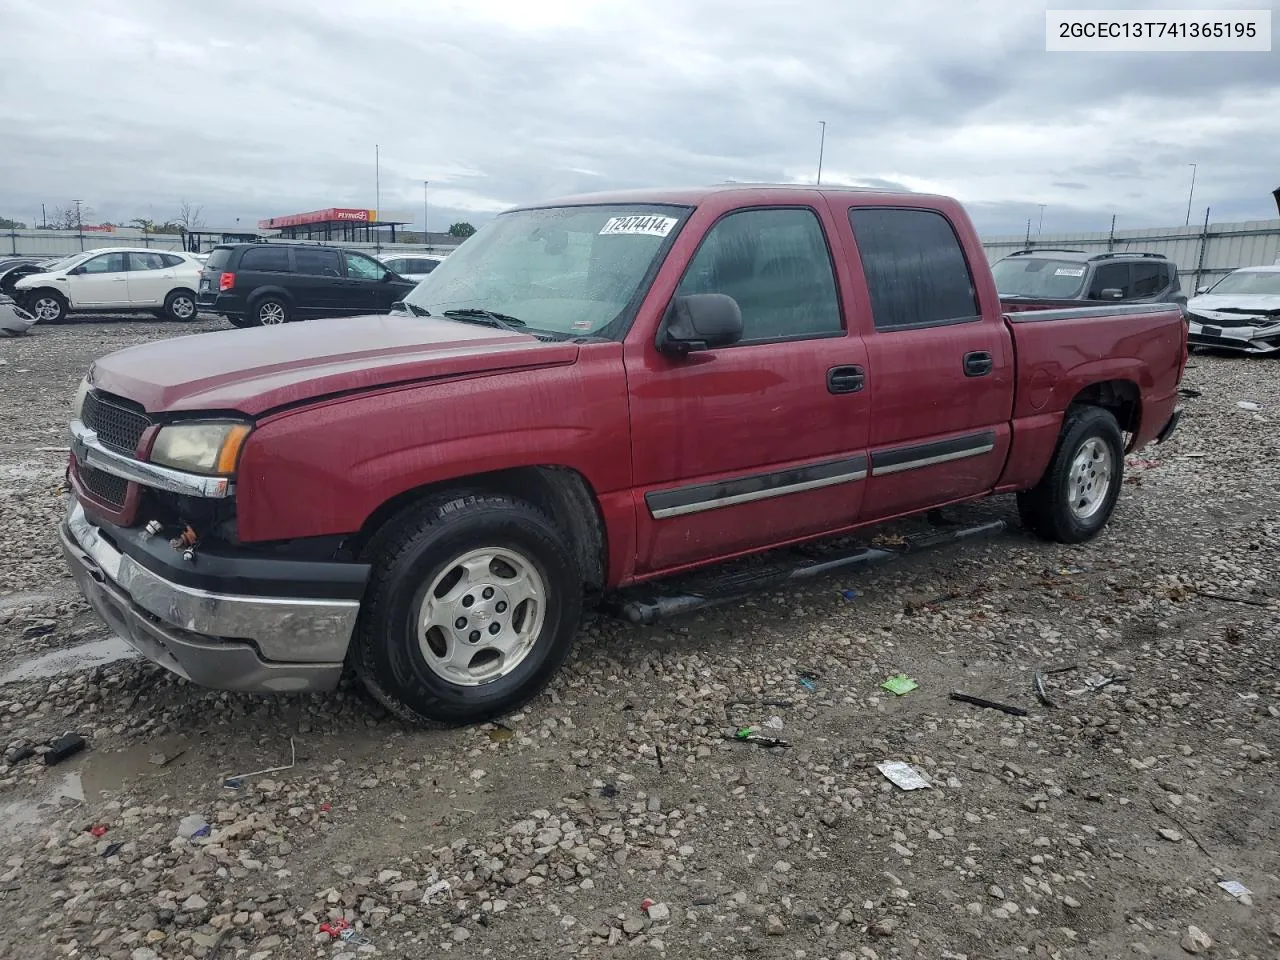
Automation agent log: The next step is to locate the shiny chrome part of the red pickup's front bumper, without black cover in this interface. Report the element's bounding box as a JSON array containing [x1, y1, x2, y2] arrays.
[[59, 503, 367, 692]]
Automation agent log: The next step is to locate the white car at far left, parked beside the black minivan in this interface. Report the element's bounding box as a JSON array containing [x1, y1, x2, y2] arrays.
[[14, 247, 201, 321]]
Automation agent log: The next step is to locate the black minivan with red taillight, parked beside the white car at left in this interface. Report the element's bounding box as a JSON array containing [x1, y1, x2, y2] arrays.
[[196, 242, 417, 326]]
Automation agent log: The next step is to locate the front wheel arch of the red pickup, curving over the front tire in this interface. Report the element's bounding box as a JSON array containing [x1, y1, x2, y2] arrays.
[[348, 465, 608, 594]]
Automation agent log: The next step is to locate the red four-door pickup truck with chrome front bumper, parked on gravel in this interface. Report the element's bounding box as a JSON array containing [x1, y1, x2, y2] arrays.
[[61, 186, 1187, 723]]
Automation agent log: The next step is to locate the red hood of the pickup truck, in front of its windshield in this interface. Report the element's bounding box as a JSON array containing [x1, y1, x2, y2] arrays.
[[90, 314, 579, 416]]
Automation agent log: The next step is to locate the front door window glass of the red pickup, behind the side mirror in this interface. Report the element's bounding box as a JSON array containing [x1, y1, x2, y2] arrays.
[[676, 209, 844, 343]]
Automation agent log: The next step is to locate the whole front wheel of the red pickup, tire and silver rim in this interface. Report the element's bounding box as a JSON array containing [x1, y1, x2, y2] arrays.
[[349, 494, 582, 724]]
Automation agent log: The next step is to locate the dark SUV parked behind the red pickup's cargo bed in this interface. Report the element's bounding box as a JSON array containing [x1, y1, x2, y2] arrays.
[[991, 247, 1187, 311]]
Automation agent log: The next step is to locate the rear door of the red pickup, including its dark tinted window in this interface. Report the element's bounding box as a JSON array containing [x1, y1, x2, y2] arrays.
[[847, 206, 1014, 520]]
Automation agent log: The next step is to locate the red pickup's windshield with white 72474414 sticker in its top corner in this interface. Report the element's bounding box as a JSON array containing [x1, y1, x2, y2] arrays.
[[404, 204, 689, 337]]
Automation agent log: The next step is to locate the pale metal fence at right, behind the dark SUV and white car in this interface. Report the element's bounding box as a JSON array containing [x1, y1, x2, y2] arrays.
[[982, 218, 1280, 296]]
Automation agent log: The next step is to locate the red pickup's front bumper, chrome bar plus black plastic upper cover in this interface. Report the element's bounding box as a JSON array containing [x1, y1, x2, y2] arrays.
[[59, 502, 369, 692]]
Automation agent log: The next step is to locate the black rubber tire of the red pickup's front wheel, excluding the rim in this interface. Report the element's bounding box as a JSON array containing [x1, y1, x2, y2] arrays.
[[348, 494, 582, 726]]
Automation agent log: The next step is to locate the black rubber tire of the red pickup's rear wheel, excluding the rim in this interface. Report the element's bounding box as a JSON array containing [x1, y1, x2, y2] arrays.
[[1018, 407, 1124, 543]]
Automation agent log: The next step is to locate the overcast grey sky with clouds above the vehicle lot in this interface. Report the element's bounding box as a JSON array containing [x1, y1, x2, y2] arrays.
[[0, 0, 1280, 234]]
